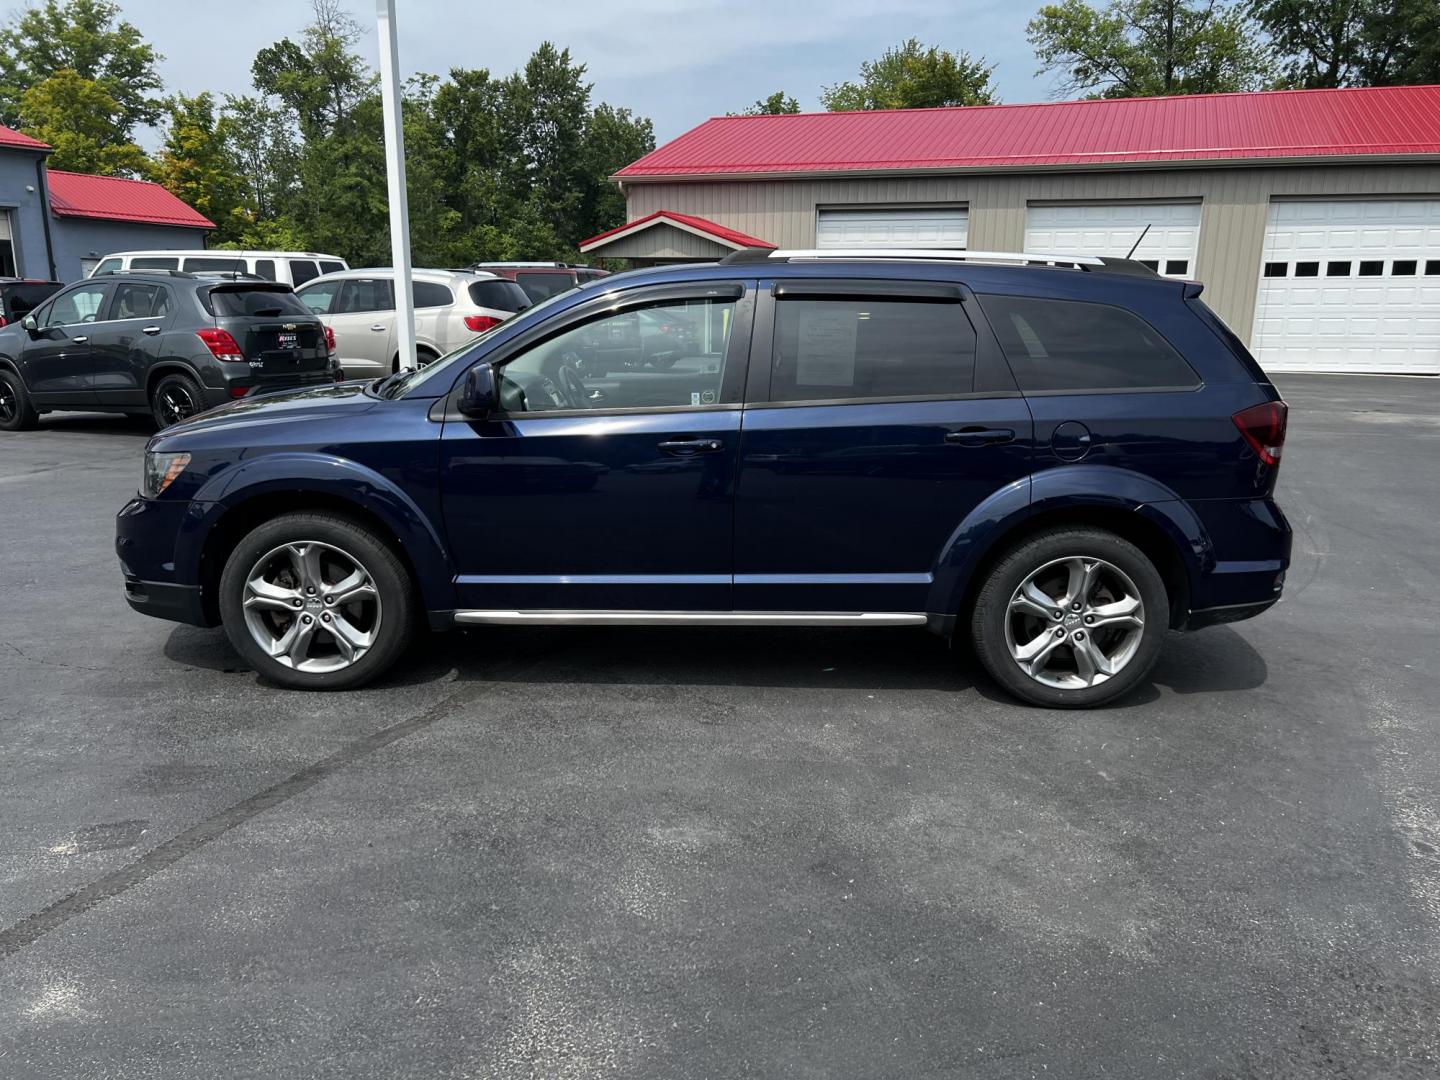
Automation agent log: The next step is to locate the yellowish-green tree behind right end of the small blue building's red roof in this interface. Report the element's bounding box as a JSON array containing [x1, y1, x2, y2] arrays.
[[151, 94, 243, 243]]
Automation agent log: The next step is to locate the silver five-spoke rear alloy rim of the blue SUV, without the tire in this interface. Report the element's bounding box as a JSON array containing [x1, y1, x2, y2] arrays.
[[1005, 556, 1145, 690]]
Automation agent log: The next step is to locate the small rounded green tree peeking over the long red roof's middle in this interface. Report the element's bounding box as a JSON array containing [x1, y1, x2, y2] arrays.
[[819, 37, 995, 112]]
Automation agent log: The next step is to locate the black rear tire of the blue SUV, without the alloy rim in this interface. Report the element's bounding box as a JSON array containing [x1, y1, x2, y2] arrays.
[[971, 528, 1169, 708]]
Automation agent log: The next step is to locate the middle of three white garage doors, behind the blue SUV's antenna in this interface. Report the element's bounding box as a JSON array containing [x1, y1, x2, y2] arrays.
[[1025, 203, 1200, 278]]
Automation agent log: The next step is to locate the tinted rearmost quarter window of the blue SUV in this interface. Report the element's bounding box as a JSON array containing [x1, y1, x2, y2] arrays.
[[979, 295, 1200, 393]]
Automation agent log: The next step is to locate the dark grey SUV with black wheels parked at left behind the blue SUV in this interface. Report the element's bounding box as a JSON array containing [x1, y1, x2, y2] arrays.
[[0, 271, 340, 431]]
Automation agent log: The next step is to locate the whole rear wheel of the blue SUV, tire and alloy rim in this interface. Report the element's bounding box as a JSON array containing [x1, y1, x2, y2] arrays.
[[971, 528, 1169, 708]]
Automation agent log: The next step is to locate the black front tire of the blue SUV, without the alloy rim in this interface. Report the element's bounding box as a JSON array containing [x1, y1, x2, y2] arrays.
[[219, 514, 415, 690]]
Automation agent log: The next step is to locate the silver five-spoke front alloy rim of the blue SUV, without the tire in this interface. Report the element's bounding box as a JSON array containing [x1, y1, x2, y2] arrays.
[[242, 540, 380, 672]]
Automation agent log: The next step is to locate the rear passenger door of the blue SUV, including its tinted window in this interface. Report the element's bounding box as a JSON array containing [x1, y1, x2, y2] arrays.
[[734, 279, 1034, 613]]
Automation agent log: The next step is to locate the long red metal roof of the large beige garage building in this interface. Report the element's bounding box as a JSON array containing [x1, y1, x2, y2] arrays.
[[616, 86, 1440, 180]]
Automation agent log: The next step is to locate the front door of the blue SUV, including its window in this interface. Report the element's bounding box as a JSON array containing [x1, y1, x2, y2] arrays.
[[441, 282, 753, 611]]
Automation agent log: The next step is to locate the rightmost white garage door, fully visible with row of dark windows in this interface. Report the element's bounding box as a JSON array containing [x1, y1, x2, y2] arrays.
[[1250, 199, 1440, 374]]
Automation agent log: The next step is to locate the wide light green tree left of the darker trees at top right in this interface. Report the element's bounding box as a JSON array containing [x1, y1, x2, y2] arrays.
[[1027, 0, 1273, 98]]
